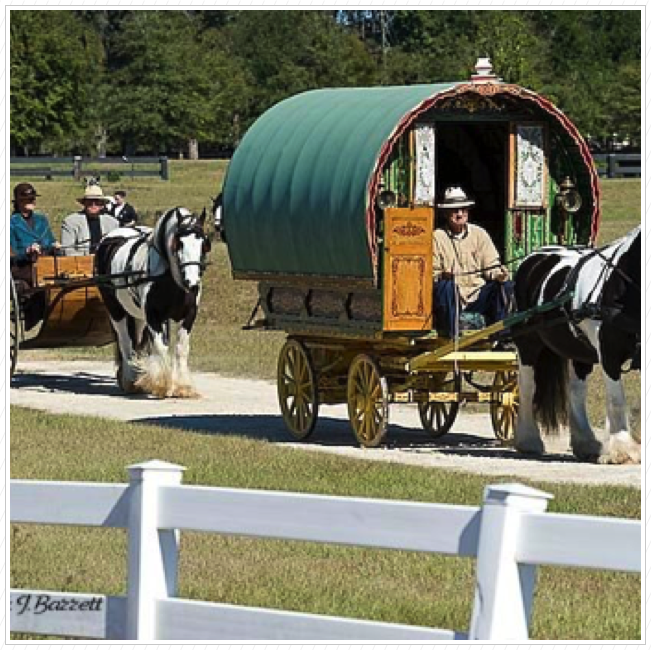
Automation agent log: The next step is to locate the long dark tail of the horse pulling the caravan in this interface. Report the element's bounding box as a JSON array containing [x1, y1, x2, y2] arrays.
[[533, 349, 570, 431]]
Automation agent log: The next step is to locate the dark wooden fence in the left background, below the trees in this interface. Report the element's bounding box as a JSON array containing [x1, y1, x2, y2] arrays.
[[10, 156, 170, 181]]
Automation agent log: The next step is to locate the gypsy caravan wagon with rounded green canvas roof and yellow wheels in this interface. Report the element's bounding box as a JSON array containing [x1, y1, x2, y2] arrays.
[[223, 59, 600, 447]]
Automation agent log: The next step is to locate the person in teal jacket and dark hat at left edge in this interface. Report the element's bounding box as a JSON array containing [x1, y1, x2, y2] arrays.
[[9, 183, 59, 264]]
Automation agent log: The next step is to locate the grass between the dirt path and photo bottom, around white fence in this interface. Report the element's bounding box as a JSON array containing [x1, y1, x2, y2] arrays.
[[11, 407, 641, 639]]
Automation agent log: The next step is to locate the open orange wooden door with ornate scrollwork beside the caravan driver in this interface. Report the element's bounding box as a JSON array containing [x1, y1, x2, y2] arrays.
[[383, 206, 434, 331]]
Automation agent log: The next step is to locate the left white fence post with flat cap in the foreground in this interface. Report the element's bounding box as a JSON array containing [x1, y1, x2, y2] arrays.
[[126, 460, 185, 640]]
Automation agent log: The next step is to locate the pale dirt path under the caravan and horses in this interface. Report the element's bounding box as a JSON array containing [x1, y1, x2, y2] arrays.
[[10, 361, 641, 488]]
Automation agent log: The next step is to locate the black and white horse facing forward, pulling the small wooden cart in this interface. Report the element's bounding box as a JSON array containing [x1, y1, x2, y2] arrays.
[[95, 208, 210, 397]]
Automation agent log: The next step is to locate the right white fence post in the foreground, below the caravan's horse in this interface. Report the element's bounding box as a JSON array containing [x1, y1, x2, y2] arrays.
[[469, 483, 553, 641]]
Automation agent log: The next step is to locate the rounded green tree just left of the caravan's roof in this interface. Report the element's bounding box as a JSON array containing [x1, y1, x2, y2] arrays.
[[106, 11, 251, 156]]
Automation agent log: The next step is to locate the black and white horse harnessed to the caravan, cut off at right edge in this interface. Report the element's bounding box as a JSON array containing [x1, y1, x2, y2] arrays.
[[512, 226, 642, 464]]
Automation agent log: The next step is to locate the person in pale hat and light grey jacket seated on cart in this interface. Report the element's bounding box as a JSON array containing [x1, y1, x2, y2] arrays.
[[61, 185, 120, 255]]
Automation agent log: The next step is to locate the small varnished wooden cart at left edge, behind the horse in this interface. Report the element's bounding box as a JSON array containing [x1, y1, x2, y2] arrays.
[[9, 255, 113, 375]]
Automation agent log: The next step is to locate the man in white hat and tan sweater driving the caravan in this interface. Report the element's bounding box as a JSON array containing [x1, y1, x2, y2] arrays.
[[434, 187, 513, 338]]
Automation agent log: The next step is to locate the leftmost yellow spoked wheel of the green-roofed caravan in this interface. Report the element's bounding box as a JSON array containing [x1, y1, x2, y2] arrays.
[[278, 340, 319, 440]]
